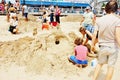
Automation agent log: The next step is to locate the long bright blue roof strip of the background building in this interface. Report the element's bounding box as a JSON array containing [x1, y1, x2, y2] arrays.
[[20, 0, 89, 7]]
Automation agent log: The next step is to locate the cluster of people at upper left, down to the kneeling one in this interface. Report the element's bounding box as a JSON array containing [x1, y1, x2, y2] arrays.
[[1, 0, 20, 34]]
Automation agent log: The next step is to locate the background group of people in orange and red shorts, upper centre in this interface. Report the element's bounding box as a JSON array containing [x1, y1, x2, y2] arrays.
[[42, 5, 61, 30]]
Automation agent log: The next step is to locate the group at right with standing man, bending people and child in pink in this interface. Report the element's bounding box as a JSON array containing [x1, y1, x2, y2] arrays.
[[69, 0, 120, 80]]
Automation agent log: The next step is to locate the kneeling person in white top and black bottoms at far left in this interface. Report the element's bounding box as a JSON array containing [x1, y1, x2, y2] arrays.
[[9, 16, 18, 34]]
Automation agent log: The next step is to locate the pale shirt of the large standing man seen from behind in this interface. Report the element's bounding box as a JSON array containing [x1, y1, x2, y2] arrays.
[[95, 14, 120, 46]]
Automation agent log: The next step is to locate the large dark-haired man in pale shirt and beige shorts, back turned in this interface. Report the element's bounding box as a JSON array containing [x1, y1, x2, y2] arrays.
[[91, 1, 120, 80]]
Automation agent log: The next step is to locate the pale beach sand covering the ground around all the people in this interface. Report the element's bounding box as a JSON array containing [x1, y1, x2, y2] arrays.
[[0, 15, 120, 80]]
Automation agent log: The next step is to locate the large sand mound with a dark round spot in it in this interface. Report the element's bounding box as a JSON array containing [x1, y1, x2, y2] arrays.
[[0, 26, 84, 80]]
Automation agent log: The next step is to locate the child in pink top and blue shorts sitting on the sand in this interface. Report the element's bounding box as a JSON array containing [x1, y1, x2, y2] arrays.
[[68, 38, 90, 66]]
